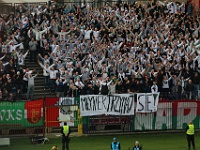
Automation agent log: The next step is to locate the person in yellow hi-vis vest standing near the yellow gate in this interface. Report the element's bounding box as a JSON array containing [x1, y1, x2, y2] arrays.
[[61, 122, 71, 150]]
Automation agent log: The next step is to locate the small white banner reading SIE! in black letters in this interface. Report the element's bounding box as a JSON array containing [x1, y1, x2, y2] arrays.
[[136, 93, 160, 113]]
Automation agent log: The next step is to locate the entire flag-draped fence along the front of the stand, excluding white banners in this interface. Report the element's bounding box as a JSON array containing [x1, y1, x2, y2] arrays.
[[0, 97, 200, 136]]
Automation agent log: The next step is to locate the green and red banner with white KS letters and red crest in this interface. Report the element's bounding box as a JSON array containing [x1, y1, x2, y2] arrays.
[[0, 100, 43, 128]]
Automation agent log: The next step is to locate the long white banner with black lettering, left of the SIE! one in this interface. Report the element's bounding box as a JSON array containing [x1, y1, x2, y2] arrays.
[[80, 94, 134, 116]]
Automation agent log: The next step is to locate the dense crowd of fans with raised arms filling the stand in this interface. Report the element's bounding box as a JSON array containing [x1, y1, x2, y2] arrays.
[[0, 1, 200, 100]]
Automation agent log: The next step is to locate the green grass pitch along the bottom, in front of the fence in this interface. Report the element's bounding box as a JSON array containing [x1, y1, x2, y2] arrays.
[[0, 133, 200, 150]]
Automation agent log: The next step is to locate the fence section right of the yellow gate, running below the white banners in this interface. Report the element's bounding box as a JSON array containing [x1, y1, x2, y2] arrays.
[[86, 101, 200, 134]]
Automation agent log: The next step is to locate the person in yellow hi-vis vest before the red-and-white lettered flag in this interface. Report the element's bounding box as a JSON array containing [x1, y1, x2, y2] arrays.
[[186, 121, 195, 150]]
